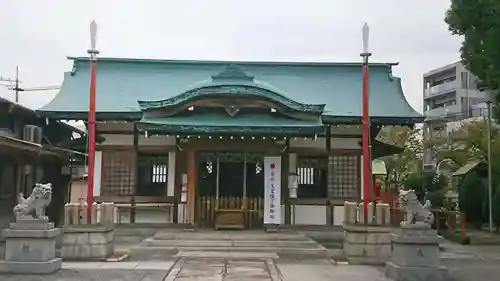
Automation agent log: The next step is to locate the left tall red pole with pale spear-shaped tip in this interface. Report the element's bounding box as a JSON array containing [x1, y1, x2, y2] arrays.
[[87, 21, 99, 220]]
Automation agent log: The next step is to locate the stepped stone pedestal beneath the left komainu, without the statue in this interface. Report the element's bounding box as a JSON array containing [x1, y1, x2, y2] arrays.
[[0, 219, 62, 274]]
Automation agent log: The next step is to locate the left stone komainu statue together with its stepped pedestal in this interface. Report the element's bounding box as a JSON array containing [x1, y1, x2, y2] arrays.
[[0, 183, 62, 274]]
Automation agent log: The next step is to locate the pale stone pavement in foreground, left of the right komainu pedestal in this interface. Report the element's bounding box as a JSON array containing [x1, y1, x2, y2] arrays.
[[0, 258, 385, 281]]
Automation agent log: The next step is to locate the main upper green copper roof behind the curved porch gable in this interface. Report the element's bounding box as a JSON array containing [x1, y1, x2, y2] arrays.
[[38, 58, 423, 124]]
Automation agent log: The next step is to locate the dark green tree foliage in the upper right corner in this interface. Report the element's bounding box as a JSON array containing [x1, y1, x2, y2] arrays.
[[445, 0, 500, 119]]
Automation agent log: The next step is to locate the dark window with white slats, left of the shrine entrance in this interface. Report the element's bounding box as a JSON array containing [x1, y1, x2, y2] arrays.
[[136, 154, 168, 196]]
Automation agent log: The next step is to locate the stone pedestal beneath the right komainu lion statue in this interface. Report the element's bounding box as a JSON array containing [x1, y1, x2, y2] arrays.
[[385, 223, 448, 281]]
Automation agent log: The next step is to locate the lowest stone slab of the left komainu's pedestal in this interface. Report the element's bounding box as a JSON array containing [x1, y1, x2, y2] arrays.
[[0, 258, 62, 274]]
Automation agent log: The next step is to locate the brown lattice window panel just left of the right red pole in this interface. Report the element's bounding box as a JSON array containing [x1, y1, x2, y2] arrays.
[[329, 155, 360, 198]]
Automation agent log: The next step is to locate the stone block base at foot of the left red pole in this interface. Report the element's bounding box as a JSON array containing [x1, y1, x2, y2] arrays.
[[61, 224, 115, 260]]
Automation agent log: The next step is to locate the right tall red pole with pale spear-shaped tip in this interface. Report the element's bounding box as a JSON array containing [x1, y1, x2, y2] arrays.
[[361, 23, 372, 222]]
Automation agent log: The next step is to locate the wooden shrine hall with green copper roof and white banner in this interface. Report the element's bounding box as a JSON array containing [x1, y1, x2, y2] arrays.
[[38, 57, 422, 228]]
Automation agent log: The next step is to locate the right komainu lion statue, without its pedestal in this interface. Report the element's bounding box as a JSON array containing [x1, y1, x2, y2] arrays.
[[398, 189, 434, 225]]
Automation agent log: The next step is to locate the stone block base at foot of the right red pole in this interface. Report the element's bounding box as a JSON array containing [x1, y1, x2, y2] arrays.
[[343, 224, 392, 265]]
